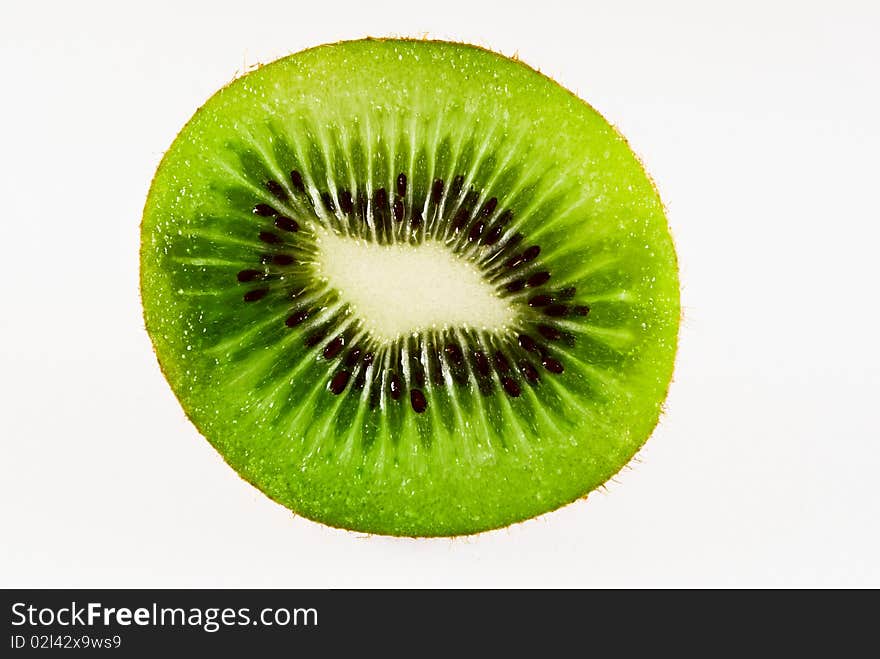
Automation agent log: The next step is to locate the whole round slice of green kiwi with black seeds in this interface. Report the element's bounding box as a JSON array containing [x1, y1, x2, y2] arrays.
[[141, 40, 679, 536]]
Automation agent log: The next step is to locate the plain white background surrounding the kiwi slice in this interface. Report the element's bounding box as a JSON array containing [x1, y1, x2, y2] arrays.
[[0, 0, 880, 587]]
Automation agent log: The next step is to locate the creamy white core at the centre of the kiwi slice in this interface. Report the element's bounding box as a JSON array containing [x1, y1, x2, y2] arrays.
[[315, 230, 516, 342]]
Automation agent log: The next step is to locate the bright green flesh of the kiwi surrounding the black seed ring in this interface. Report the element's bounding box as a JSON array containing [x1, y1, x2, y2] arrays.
[[141, 40, 679, 536]]
